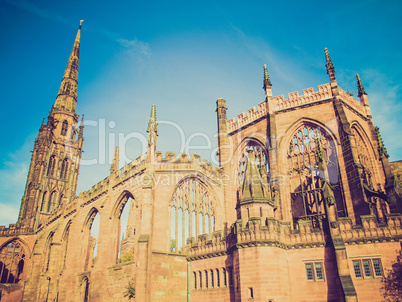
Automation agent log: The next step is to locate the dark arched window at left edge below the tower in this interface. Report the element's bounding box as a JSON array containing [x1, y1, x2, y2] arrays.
[[0, 240, 25, 283]]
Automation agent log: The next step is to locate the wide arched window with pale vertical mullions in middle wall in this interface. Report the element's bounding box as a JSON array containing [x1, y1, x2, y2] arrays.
[[170, 178, 215, 252]]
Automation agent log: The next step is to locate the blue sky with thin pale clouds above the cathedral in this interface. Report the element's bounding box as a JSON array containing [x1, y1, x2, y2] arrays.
[[0, 0, 402, 225]]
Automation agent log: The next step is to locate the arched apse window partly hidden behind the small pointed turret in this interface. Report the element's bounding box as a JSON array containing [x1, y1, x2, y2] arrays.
[[237, 140, 269, 186]]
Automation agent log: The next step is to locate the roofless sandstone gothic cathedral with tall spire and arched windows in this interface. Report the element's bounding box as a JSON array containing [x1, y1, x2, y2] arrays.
[[0, 26, 402, 302]]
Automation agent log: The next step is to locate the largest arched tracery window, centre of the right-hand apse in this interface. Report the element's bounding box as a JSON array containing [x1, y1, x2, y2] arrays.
[[287, 124, 346, 227]]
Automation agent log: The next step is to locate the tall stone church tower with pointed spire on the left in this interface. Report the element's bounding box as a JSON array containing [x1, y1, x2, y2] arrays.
[[18, 21, 84, 229]]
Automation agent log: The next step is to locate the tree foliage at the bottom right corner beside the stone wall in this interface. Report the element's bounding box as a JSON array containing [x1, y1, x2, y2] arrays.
[[381, 250, 402, 302]]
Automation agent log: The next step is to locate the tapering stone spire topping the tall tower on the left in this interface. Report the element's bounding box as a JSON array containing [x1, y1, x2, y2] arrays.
[[54, 20, 83, 114]]
